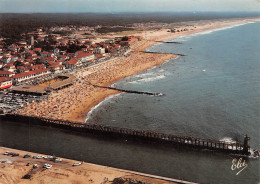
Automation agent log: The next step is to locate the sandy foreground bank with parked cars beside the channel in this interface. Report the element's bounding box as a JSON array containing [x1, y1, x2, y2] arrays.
[[0, 147, 184, 184]]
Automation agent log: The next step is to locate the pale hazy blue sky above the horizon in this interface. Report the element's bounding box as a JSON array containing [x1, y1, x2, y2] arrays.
[[0, 0, 260, 13]]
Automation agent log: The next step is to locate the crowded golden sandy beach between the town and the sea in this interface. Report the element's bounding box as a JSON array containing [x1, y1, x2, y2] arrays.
[[14, 19, 256, 123]]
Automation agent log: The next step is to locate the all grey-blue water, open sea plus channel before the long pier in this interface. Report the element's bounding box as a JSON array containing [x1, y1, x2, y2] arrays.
[[0, 22, 260, 184]]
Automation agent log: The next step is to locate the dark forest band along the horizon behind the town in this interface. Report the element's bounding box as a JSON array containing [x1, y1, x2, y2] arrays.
[[0, 12, 260, 41]]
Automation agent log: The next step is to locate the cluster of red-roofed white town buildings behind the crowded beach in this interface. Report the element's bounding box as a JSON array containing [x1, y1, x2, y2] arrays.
[[0, 26, 140, 89]]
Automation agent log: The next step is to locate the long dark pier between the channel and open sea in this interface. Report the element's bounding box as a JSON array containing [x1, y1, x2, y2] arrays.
[[1, 114, 250, 155]]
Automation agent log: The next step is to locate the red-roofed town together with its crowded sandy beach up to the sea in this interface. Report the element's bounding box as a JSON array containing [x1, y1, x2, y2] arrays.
[[0, 19, 256, 123]]
